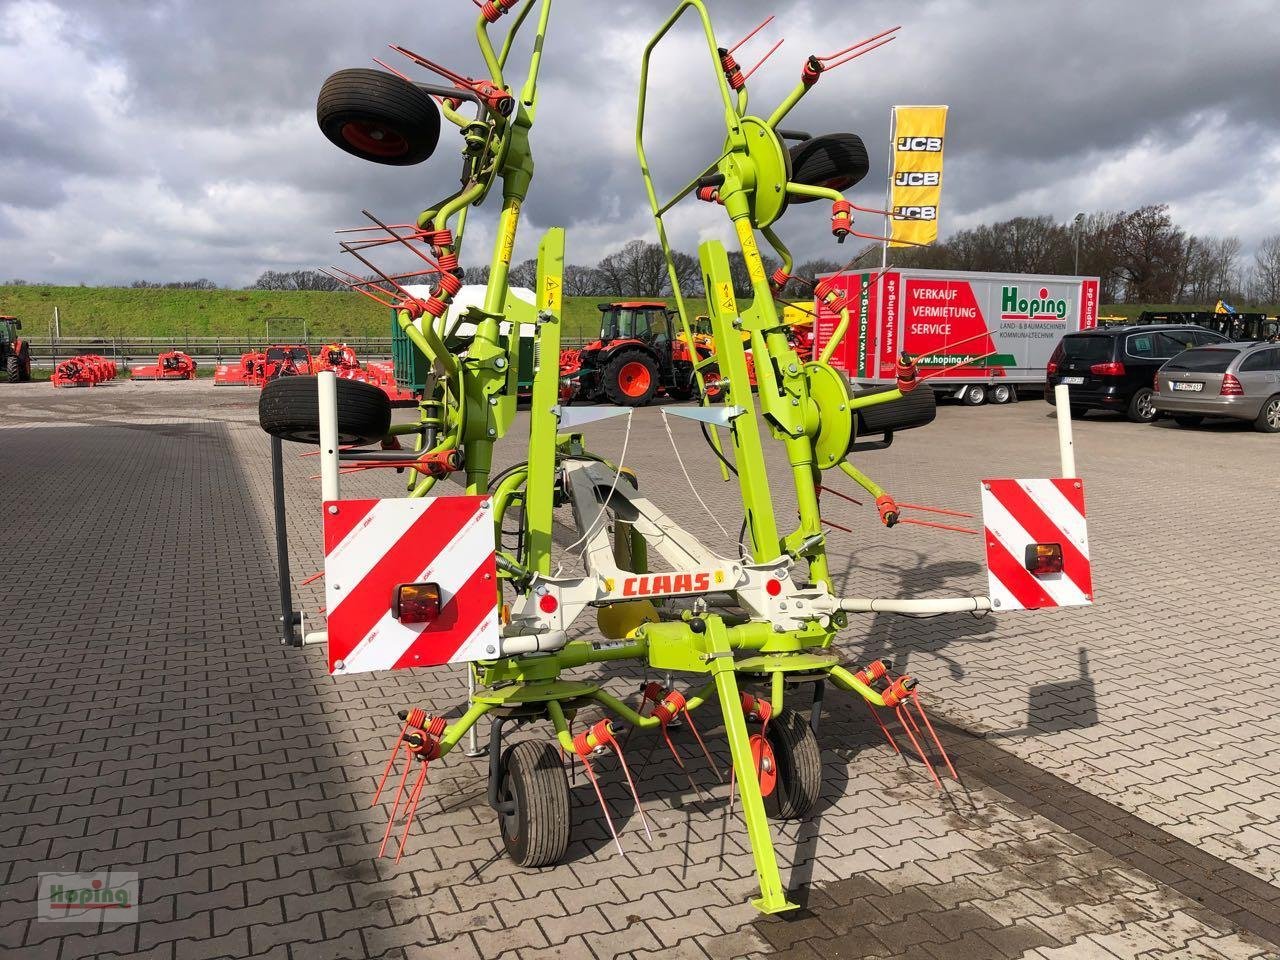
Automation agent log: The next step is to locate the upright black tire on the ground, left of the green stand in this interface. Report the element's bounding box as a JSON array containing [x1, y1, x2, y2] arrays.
[[498, 740, 570, 868]]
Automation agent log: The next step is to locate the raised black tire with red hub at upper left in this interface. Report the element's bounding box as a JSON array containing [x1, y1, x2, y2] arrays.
[[316, 67, 440, 166]]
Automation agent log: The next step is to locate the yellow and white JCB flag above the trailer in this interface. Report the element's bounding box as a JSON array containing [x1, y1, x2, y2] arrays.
[[888, 106, 947, 247]]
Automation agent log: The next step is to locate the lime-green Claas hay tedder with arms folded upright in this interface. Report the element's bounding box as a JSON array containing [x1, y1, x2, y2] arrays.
[[260, 0, 1092, 913]]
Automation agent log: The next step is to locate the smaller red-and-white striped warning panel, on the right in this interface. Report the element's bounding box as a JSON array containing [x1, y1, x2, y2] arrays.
[[982, 477, 1093, 611]]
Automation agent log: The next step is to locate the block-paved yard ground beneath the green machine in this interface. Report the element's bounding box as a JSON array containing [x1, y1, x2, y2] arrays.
[[0, 383, 1280, 960]]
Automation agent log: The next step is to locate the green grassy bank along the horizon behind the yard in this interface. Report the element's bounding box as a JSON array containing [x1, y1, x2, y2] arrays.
[[0, 285, 1275, 344]]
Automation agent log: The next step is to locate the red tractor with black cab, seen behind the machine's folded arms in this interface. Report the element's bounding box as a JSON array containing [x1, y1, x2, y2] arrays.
[[561, 301, 719, 407]]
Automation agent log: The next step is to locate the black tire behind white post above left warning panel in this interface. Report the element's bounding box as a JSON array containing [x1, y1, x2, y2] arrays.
[[257, 376, 392, 447]]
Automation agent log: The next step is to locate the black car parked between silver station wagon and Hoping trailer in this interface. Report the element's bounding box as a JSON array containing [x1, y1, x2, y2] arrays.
[[1044, 324, 1228, 424]]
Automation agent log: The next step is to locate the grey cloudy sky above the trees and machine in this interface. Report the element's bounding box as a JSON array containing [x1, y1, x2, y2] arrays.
[[0, 0, 1280, 285]]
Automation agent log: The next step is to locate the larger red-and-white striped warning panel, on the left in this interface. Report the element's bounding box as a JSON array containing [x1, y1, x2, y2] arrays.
[[324, 497, 499, 675]]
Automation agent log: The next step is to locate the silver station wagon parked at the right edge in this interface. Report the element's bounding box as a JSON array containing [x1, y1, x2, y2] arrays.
[[1152, 343, 1280, 434]]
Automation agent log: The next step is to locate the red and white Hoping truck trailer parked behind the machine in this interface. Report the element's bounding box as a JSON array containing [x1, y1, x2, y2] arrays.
[[814, 268, 1098, 406]]
